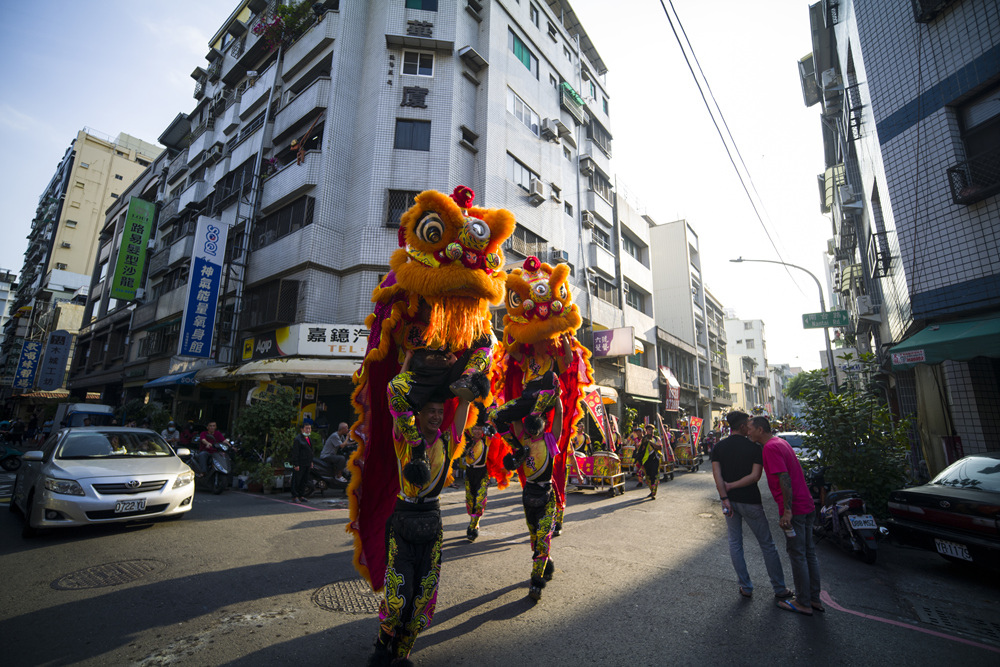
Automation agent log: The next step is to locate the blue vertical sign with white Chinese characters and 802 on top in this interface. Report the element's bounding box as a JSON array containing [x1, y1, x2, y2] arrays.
[[177, 215, 228, 358]]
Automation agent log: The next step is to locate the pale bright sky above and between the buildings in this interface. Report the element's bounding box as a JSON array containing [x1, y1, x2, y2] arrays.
[[0, 0, 832, 369]]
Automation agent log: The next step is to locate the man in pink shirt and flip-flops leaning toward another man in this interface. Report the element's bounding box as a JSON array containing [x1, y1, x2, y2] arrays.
[[747, 417, 826, 616]]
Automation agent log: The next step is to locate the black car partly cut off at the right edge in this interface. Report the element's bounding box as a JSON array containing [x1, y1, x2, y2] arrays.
[[889, 452, 1000, 568]]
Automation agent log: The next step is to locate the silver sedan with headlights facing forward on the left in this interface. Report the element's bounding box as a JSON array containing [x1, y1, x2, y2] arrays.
[[10, 426, 194, 537]]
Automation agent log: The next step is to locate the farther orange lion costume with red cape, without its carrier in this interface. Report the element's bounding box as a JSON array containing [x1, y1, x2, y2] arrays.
[[490, 257, 594, 535]]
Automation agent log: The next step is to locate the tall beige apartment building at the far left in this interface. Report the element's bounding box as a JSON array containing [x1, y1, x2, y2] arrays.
[[2, 128, 162, 396]]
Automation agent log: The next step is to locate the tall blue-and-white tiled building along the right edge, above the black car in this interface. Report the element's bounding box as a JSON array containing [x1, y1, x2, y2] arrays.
[[799, 0, 1000, 471]]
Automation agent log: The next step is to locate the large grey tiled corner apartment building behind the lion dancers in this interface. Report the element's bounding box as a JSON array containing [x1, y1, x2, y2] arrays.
[[94, 0, 632, 422]]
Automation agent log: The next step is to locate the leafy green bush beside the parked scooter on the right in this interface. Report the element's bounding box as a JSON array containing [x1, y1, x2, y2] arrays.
[[793, 353, 909, 517]]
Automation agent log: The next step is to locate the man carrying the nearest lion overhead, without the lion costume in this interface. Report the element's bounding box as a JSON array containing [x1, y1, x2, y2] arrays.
[[368, 392, 469, 665]]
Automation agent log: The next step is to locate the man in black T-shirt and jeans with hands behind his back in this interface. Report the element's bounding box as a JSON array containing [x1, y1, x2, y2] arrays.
[[711, 410, 792, 600]]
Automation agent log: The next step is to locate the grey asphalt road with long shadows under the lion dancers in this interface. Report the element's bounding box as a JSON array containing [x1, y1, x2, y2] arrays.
[[0, 472, 1000, 667]]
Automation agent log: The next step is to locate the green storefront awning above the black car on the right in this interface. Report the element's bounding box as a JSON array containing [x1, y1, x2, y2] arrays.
[[890, 315, 1000, 368]]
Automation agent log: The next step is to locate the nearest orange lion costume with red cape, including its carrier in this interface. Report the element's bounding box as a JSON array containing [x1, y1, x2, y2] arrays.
[[348, 187, 515, 664]]
